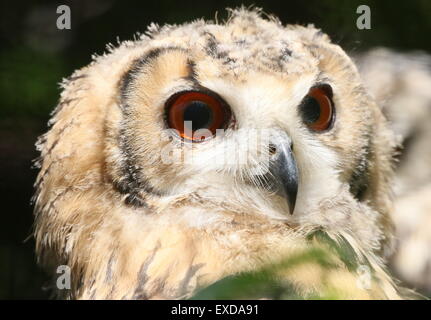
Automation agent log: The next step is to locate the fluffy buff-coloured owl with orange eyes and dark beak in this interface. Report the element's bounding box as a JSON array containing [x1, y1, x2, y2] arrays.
[[34, 8, 408, 299]]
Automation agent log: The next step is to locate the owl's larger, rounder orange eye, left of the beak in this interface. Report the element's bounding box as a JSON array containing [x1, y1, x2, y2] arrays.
[[166, 91, 230, 142]]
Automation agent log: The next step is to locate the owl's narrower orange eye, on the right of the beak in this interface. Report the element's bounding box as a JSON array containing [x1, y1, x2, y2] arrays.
[[300, 85, 335, 132]]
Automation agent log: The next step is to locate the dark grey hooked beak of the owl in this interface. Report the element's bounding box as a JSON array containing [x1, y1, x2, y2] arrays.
[[269, 143, 299, 214]]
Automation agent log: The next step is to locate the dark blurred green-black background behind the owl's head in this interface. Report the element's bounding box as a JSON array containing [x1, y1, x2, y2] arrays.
[[0, 0, 431, 299]]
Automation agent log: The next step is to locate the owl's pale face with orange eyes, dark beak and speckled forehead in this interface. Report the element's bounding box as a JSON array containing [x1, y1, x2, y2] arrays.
[[113, 14, 384, 225]]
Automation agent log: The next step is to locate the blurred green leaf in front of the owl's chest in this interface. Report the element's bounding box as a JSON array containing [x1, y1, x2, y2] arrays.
[[192, 230, 371, 300]]
